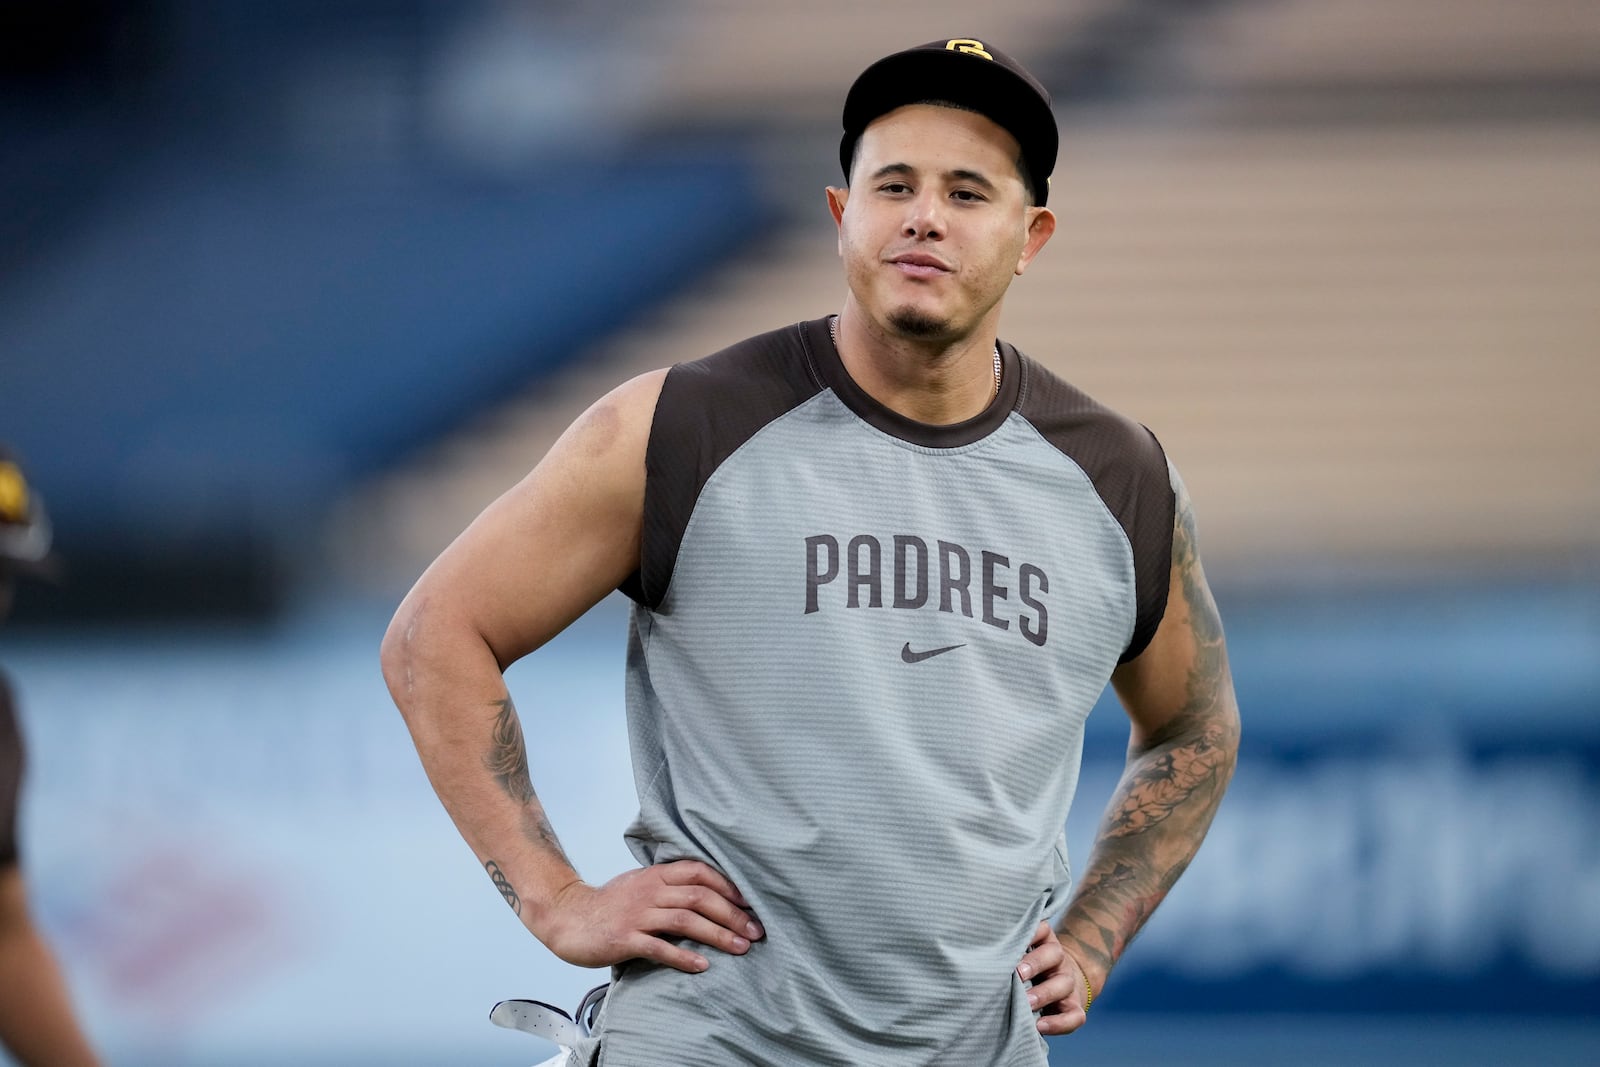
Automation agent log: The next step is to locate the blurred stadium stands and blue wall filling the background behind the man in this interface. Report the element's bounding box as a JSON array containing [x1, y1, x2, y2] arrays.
[[0, 0, 1600, 1064]]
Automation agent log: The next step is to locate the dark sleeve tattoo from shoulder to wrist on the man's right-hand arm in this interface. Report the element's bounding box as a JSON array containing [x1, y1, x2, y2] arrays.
[[1069, 470, 1238, 974]]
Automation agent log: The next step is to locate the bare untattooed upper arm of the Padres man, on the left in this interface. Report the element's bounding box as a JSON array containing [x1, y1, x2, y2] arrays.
[[402, 371, 666, 669]]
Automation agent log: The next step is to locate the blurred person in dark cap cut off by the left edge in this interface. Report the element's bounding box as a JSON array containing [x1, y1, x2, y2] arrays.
[[0, 451, 98, 1067]]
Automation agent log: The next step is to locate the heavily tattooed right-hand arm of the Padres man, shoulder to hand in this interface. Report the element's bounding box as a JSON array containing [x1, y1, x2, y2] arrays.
[[1024, 470, 1238, 1033]]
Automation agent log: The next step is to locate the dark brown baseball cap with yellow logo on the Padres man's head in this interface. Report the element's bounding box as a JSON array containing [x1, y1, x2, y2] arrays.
[[838, 37, 1061, 205]]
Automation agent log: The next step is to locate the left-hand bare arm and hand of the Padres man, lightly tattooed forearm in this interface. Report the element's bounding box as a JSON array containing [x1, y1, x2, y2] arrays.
[[382, 373, 760, 971]]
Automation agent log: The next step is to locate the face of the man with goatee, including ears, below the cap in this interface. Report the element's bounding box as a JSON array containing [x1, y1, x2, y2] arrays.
[[829, 104, 1054, 342]]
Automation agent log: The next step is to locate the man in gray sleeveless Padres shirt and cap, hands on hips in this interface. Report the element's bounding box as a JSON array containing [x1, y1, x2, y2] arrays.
[[384, 40, 1238, 1065]]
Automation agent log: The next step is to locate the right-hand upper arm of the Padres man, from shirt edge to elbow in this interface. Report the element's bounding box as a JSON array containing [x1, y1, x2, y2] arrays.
[[1112, 460, 1238, 750]]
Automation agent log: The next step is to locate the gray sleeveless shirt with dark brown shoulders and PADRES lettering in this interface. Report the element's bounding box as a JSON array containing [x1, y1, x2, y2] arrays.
[[598, 318, 1173, 1067]]
